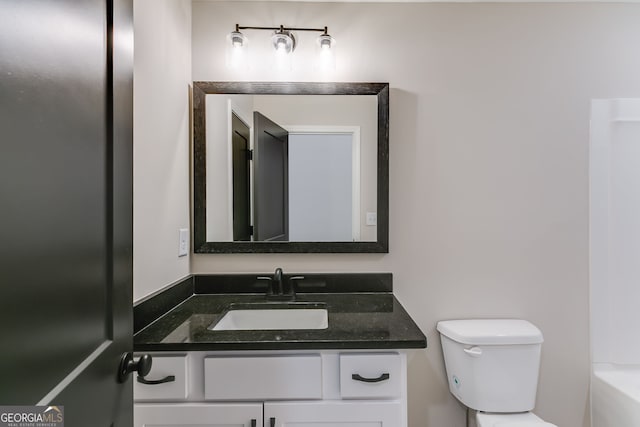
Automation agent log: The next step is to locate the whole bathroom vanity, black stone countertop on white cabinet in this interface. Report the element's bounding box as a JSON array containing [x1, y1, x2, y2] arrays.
[[134, 274, 426, 427]]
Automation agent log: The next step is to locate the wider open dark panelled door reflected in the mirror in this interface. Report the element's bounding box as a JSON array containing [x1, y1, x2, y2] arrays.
[[253, 111, 289, 241]]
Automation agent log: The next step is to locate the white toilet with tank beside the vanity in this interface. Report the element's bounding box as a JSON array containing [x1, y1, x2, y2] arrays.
[[437, 319, 555, 427]]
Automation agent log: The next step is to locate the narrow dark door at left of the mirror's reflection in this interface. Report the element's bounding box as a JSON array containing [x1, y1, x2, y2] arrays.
[[231, 114, 251, 241]]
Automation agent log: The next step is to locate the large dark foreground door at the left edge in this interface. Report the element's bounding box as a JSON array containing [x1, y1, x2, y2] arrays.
[[0, 0, 133, 427]]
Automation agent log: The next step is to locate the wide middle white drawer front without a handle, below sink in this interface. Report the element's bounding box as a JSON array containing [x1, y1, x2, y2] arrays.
[[204, 354, 322, 400]]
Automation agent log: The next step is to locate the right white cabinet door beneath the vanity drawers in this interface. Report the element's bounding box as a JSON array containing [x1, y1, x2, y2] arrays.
[[264, 401, 407, 427]]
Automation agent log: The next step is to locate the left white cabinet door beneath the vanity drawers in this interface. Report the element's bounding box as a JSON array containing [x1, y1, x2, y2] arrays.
[[133, 403, 262, 427]]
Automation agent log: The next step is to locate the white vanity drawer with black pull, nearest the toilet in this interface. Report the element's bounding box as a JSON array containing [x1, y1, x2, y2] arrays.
[[340, 353, 403, 399]]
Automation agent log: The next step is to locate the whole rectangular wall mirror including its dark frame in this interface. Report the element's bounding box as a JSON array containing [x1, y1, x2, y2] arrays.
[[193, 82, 389, 253]]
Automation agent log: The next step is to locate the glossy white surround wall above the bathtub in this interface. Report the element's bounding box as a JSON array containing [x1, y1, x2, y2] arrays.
[[590, 99, 640, 365]]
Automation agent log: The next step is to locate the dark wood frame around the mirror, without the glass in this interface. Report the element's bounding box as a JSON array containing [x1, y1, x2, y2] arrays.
[[193, 81, 389, 254]]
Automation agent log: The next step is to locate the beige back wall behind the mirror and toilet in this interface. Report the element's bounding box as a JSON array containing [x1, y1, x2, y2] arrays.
[[192, 2, 640, 427]]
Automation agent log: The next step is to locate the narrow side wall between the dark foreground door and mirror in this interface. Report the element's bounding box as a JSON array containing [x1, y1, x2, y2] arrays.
[[133, 0, 191, 301]]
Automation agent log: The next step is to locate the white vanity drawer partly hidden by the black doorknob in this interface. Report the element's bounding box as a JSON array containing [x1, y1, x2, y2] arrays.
[[133, 355, 188, 401]]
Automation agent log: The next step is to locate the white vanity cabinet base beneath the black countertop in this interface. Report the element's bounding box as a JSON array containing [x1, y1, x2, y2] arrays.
[[134, 350, 407, 427]]
